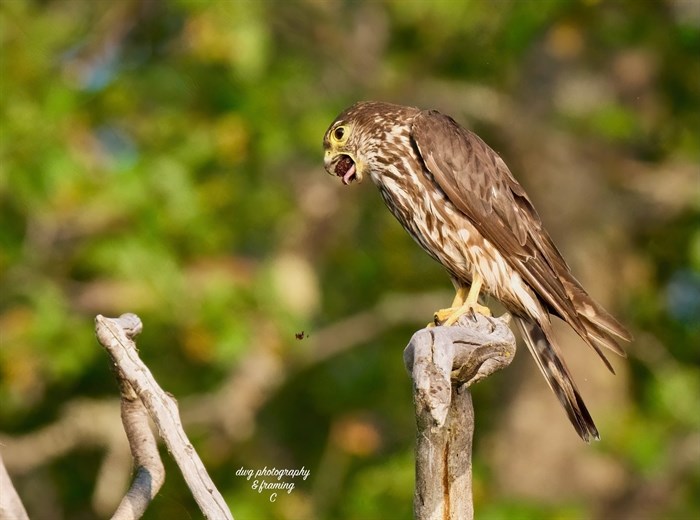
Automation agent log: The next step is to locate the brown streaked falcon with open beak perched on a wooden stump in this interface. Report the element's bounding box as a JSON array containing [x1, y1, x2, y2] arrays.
[[323, 101, 632, 442]]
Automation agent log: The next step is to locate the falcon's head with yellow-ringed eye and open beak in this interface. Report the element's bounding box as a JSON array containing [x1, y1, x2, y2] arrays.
[[323, 101, 417, 185]]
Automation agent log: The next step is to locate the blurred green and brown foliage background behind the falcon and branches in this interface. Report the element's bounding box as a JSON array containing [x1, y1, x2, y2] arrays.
[[0, 0, 700, 520]]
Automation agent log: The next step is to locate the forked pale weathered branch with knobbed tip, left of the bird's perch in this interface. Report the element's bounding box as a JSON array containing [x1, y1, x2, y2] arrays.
[[95, 314, 233, 520]]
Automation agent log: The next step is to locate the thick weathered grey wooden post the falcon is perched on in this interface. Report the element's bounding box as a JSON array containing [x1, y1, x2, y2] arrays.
[[404, 314, 515, 520]]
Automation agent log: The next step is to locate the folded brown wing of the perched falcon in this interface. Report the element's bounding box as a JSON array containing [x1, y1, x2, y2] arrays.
[[412, 110, 631, 370]]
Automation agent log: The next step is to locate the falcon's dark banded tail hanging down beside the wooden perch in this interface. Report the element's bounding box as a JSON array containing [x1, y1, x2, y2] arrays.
[[516, 318, 600, 442]]
